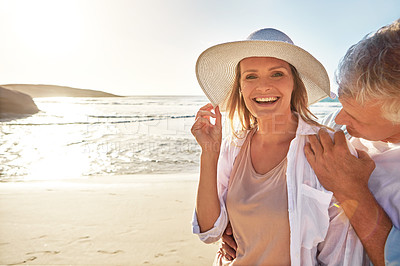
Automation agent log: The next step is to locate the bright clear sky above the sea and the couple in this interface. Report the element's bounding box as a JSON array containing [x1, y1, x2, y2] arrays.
[[0, 0, 400, 95]]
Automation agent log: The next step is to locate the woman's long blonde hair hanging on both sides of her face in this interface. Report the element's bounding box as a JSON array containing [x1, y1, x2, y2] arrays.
[[227, 59, 322, 137]]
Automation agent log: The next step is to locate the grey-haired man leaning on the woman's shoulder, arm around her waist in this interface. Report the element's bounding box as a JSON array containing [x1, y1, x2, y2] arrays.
[[223, 19, 400, 265]]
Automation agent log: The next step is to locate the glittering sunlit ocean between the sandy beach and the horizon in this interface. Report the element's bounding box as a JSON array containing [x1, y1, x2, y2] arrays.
[[0, 96, 340, 181]]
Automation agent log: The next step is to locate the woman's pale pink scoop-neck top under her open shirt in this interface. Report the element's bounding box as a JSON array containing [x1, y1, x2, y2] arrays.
[[220, 130, 290, 265]]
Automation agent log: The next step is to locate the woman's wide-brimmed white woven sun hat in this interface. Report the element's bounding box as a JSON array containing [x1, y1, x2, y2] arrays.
[[196, 28, 330, 111]]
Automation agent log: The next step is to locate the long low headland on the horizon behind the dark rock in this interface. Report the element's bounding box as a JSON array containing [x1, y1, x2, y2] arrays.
[[0, 84, 123, 98]]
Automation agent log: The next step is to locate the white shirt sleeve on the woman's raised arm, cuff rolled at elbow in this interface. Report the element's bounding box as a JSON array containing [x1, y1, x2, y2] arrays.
[[192, 138, 234, 243]]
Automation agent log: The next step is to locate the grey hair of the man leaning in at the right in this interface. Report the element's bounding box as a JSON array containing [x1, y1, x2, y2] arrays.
[[336, 19, 400, 123]]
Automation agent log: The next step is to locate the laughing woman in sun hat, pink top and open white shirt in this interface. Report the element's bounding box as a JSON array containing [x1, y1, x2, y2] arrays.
[[192, 29, 366, 265]]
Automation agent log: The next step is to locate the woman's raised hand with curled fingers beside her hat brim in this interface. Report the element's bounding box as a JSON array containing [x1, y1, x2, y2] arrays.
[[191, 103, 222, 154]]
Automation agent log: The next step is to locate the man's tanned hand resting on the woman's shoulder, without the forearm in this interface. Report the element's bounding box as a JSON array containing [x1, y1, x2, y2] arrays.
[[304, 129, 375, 201]]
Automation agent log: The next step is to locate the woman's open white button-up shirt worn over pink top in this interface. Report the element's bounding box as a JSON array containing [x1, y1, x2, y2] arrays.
[[192, 117, 367, 266]]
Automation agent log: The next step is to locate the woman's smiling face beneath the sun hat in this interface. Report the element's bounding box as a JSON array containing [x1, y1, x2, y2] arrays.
[[239, 57, 294, 118]]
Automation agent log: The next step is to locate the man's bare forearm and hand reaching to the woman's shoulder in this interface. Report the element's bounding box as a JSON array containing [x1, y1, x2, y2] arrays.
[[304, 129, 392, 266]]
